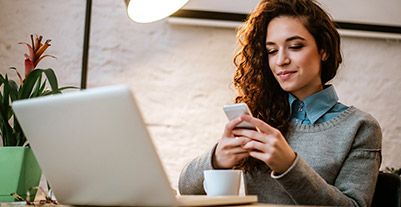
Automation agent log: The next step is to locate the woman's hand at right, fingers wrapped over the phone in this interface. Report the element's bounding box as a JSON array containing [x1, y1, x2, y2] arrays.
[[232, 115, 296, 174]]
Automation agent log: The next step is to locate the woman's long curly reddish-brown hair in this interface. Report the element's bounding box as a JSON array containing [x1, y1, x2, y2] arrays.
[[234, 0, 342, 171]]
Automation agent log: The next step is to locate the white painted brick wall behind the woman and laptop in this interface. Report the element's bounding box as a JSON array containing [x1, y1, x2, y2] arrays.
[[0, 0, 401, 186]]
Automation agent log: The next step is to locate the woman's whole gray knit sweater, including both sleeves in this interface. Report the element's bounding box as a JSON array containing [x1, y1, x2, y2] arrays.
[[179, 107, 382, 206]]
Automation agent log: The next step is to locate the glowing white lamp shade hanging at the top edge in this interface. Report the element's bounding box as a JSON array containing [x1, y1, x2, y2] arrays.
[[125, 0, 189, 23]]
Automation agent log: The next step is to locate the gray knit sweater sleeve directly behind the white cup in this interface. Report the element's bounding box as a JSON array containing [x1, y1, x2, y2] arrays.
[[178, 145, 217, 195]]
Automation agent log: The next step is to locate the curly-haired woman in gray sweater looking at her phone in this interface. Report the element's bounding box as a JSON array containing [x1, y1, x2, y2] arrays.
[[179, 0, 382, 206]]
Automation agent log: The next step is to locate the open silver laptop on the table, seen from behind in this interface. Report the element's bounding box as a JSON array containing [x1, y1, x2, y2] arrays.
[[12, 85, 257, 206]]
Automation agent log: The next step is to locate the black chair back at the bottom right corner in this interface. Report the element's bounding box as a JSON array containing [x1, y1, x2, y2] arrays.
[[372, 172, 401, 207]]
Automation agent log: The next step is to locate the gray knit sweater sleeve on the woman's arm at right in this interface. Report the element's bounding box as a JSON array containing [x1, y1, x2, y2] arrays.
[[273, 114, 382, 206]]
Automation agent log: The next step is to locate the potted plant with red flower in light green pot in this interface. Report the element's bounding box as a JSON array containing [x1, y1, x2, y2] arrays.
[[0, 35, 74, 202]]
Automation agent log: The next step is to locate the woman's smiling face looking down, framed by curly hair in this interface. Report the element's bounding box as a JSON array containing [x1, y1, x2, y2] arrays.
[[266, 16, 325, 100]]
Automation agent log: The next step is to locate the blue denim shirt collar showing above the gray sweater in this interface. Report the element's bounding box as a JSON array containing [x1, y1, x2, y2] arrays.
[[288, 85, 348, 125]]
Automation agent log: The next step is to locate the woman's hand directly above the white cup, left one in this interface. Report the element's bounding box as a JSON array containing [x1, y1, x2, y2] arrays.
[[213, 118, 250, 168]]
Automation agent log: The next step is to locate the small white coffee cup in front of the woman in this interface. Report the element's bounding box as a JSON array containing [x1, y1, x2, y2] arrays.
[[203, 170, 241, 196]]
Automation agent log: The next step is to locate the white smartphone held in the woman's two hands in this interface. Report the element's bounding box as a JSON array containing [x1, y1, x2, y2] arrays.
[[223, 103, 257, 131]]
